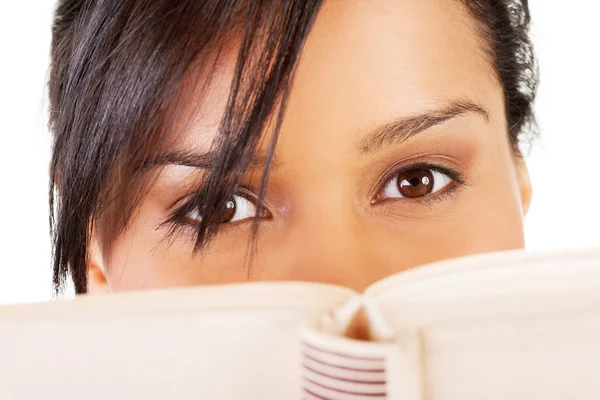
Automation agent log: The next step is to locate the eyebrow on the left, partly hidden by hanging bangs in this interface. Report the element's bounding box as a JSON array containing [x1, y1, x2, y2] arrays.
[[136, 150, 277, 171]]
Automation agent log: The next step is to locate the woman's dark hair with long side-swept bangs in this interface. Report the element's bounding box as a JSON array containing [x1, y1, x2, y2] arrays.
[[49, 0, 537, 294]]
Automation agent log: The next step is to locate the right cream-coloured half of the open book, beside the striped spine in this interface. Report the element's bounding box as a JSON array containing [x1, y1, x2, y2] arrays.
[[364, 251, 600, 400]]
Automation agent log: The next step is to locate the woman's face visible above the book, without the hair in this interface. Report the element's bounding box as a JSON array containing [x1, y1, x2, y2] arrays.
[[89, 0, 530, 291]]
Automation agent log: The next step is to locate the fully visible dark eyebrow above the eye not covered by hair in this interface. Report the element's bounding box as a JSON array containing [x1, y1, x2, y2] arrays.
[[359, 100, 490, 153]]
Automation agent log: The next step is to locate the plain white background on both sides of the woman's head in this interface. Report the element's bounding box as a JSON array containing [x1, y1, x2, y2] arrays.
[[0, 0, 600, 304]]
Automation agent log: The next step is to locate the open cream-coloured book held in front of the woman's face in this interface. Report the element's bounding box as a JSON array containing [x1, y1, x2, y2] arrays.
[[0, 251, 600, 400]]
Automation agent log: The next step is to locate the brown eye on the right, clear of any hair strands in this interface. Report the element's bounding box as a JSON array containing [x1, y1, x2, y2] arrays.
[[373, 168, 453, 203]]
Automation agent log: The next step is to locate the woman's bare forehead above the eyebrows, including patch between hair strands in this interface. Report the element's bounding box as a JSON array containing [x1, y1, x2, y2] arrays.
[[178, 0, 503, 152]]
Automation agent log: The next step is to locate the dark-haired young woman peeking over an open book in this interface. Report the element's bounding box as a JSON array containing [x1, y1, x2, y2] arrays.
[[49, 0, 537, 293]]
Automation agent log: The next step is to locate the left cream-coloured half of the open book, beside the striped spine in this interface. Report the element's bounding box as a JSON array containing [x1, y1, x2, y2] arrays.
[[0, 283, 353, 399]]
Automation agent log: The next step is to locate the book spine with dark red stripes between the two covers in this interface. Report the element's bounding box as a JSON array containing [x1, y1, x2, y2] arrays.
[[301, 297, 424, 400]]
